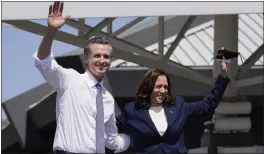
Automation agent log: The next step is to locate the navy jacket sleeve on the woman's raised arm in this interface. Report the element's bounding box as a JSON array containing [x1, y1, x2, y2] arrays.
[[183, 75, 229, 115]]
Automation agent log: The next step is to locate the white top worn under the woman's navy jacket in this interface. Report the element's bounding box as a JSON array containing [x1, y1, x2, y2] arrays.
[[149, 106, 168, 136]]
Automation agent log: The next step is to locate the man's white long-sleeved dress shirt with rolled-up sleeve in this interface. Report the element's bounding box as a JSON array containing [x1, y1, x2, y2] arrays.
[[33, 52, 130, 153]]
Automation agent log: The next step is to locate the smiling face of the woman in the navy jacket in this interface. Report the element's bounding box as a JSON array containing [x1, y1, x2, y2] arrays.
[[151, 75, 168, 106]]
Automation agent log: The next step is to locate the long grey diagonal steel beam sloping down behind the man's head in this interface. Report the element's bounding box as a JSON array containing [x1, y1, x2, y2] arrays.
[[5, 21, 212, 85]]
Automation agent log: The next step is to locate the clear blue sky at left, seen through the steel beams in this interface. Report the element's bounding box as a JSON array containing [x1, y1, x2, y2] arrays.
[[2, 17, 150, 119]]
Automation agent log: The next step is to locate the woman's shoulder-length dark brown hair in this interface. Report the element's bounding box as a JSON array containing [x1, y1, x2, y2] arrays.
[[136, 69, 173, 108]]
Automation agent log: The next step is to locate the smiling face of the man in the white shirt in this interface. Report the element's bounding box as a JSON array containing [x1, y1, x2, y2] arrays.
[[86, 44, 112, 80]]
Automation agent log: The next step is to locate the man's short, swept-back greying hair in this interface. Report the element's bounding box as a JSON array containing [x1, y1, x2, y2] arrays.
[[84, 36, 113, 55]]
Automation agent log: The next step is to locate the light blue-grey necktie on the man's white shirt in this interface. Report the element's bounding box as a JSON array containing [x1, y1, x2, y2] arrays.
[[95, 83, 105, 153]]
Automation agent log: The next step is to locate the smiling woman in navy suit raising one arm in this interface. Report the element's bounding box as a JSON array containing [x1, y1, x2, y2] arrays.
[[117, 59, 229, 154]]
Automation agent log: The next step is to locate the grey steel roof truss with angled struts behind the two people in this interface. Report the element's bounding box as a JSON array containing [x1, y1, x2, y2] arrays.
[[2, 12, 263, 87]]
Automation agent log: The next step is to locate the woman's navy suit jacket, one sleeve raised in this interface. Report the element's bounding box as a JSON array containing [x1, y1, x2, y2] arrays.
[[117, 76, 229, 154]]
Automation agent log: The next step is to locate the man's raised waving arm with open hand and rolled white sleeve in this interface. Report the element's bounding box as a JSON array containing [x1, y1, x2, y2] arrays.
[[33, 2, 70, 90]]
